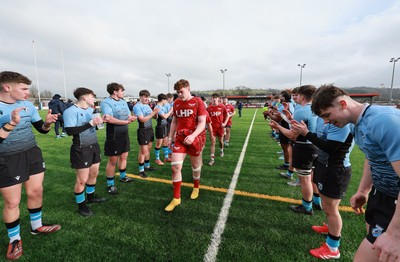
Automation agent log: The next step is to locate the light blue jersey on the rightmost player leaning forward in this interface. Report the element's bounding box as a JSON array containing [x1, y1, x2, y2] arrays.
[[354, 106, 400, 198]]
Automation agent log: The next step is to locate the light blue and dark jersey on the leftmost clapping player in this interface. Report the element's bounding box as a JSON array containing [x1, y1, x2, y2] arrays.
[[0, 101, 41, 156]]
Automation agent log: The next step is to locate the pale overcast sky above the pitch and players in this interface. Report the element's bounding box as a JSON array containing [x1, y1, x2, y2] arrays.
[[0, 0, 400, 98]]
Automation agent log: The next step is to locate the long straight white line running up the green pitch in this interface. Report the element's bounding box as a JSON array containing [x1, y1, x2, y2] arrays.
[[204, 109, 258, 262]]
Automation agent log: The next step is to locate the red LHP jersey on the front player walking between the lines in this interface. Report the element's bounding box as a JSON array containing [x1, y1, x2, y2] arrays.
[[173, 97, 207, 131]]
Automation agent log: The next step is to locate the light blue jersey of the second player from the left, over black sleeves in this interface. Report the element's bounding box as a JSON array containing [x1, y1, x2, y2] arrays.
[[63, 105, 97, 146]]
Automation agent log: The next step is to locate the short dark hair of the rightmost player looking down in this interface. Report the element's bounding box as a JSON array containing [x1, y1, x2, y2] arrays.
[[311, 84, 349, 116]]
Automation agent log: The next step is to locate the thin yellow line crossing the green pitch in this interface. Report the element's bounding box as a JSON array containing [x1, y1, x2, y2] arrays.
[[127, 174, 353, 212]]
